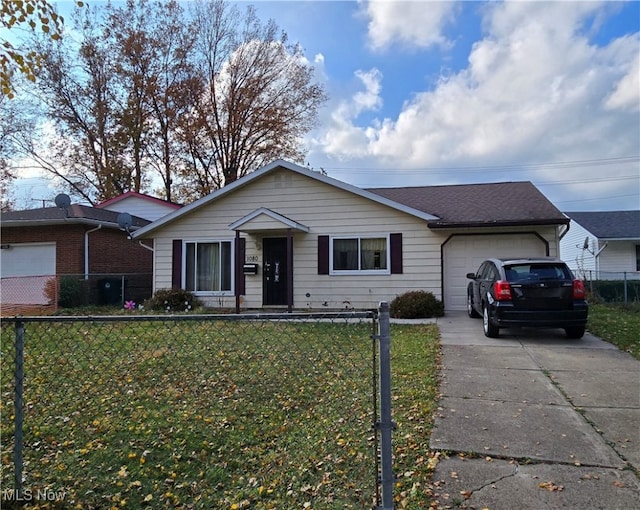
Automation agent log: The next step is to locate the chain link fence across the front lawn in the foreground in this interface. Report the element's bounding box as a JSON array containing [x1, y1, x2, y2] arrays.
[[0, 304, 394, 509]]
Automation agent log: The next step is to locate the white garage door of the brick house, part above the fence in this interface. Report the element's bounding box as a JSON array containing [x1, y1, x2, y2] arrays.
[[0, 243, 56, 278]]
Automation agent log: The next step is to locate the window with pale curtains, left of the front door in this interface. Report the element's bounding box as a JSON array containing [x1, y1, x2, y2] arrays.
[[185, 241, 233, 293]]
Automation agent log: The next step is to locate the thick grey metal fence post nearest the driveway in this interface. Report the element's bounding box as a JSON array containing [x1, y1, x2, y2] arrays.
[[377, 301, 395, 510]]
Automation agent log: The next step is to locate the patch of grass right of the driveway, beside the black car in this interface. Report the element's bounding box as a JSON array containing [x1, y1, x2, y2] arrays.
[[587, 302, 640, 359]]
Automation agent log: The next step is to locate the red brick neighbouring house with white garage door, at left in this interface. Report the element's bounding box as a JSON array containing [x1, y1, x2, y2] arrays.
[[0, 204, 153, 308]]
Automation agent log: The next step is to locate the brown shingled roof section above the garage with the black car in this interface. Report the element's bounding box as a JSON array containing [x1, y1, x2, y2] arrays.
[[367, 182, 569, 228]]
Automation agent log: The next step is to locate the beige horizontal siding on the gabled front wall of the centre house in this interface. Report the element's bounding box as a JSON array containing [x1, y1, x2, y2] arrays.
[[148, 170, 441, 309]]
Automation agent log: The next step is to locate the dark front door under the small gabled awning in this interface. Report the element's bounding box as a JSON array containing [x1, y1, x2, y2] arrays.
[[262, 237, 288, 306]]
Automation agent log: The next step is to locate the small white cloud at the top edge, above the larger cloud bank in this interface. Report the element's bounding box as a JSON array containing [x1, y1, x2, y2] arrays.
[[364, 0, 457, 49]]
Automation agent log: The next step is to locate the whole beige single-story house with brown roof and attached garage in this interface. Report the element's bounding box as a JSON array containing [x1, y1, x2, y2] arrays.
[[133, 160, 569, 311]]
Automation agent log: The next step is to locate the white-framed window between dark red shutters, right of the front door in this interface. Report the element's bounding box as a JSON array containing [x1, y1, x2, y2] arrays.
[[331, 236, 389, 274]]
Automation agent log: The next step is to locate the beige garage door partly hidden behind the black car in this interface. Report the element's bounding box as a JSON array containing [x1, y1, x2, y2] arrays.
[[443, 234, 547, 310]]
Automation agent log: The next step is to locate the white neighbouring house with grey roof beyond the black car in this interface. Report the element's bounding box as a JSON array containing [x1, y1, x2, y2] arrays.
[[560, 210, 640, 280]]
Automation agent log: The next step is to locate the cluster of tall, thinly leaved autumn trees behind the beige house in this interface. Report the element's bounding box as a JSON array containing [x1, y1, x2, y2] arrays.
[[11, 0, 326, 203]]
